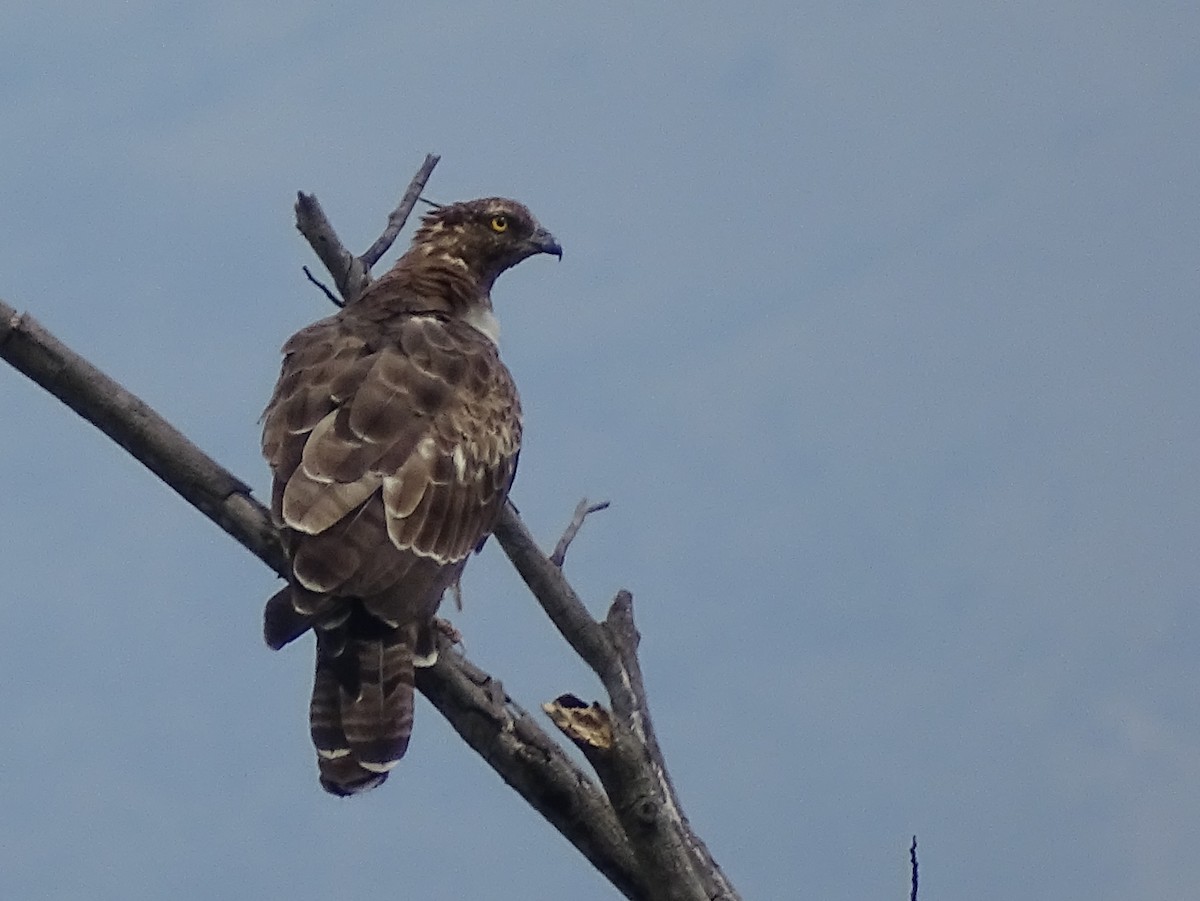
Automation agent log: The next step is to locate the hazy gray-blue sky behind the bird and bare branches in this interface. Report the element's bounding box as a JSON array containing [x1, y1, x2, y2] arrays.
[[0, 2, 1200, 901]]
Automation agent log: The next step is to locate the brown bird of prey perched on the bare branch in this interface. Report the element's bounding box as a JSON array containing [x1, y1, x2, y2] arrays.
[[263, 198, 563, 795]]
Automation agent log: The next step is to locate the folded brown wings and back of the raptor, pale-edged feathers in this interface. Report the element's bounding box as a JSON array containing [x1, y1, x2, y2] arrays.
[[263, 316, 520, 609]]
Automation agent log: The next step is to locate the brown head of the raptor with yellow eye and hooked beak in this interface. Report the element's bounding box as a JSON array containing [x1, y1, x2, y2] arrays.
[[413, 197, 563, 287]]
